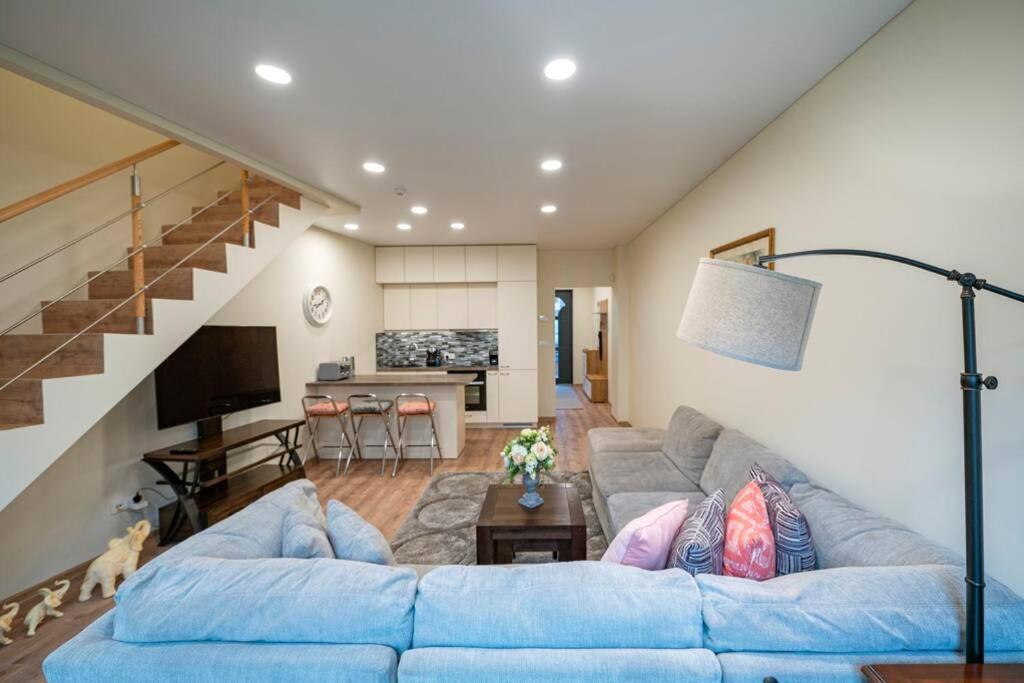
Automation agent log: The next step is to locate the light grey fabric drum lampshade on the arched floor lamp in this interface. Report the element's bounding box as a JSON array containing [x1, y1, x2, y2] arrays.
[[676, 258, 821, 370]]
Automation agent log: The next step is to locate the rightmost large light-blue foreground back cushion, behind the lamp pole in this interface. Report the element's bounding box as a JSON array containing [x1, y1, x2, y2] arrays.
[[696, 564, 1024, 652]]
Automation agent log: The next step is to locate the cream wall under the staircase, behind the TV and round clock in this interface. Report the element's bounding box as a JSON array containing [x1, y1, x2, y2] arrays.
[[0, 228, 383, 596]]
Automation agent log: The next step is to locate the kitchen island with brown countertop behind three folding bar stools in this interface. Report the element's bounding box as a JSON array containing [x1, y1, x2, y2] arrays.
[[306, 372, 473, 459]]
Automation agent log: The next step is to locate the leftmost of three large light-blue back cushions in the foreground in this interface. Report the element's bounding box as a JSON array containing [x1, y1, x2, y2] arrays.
[[114, 557, 416, 652]]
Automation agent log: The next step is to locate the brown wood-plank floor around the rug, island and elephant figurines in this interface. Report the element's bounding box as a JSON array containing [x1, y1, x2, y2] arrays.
[[0, 386, 616, 683]]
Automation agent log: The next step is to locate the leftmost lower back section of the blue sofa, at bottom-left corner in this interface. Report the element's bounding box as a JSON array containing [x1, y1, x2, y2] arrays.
[[43, 610, 398, 683]]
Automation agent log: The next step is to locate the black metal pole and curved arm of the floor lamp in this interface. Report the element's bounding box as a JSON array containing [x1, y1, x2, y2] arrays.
[[758, 249, 1024, 664]]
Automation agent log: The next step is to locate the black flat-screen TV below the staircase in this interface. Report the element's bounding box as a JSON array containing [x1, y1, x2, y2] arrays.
[[156, 325, 281, 429]]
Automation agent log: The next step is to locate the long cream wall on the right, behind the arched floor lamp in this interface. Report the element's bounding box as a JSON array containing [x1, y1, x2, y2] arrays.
[[616, 0, 1024, 591]]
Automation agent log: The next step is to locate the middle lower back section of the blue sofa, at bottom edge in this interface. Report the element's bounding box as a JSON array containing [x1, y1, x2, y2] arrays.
[[398, 647, 721, 683]]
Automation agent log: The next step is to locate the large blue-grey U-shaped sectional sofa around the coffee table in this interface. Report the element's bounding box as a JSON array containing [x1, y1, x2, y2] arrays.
[[43, 408, 1024, 683]]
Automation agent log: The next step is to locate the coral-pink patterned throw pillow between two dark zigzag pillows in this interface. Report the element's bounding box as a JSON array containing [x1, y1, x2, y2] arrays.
[[723, 481, 775, 581]]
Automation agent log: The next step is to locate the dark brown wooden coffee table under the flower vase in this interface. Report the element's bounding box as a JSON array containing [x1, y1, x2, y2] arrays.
[[476, 483, 587, 564]]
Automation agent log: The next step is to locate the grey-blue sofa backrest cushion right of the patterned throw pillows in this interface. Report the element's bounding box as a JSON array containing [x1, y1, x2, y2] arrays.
[[790, 483, 964, 569]]
